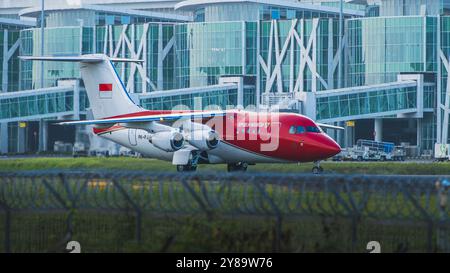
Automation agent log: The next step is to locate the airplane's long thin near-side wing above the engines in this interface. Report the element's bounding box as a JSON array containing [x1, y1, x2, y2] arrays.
[[57, 111, 226, 125]]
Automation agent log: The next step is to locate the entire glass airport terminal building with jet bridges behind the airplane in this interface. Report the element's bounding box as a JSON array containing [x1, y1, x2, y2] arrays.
[[0, 0, 450, 155]]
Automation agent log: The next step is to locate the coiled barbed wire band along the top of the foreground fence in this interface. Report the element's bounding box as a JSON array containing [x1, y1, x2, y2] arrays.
[[0, 171, 448, 220]]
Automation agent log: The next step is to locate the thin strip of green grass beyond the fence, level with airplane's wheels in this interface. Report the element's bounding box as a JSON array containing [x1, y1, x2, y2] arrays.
[[0, 157, 450, 175]]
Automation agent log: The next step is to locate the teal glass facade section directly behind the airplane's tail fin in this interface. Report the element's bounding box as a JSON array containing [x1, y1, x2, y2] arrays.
[[21, 24, 175, 93]]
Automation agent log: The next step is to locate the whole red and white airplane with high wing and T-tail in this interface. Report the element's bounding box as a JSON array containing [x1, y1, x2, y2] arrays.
[[20, 54, 343, 173]]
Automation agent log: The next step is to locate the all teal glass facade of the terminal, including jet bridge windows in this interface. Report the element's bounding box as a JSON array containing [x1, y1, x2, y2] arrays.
[[0, 4, 450, 153]]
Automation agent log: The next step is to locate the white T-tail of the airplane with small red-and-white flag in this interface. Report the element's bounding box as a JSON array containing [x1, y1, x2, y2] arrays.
[[19, 54, 144, 119]]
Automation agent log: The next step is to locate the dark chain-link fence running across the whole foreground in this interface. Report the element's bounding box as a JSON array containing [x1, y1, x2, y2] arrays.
[[0, 171, 450, 252]]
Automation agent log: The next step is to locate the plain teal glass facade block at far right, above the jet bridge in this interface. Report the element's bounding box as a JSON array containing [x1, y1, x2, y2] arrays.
[[347, 16, 437, 86]]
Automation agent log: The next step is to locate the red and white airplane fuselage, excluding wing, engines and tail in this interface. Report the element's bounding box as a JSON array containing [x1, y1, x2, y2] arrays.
[[94, 111, 340, 164]]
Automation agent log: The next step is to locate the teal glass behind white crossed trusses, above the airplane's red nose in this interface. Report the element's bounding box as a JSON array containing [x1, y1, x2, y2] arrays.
[[259, 19, 339, 92]]
